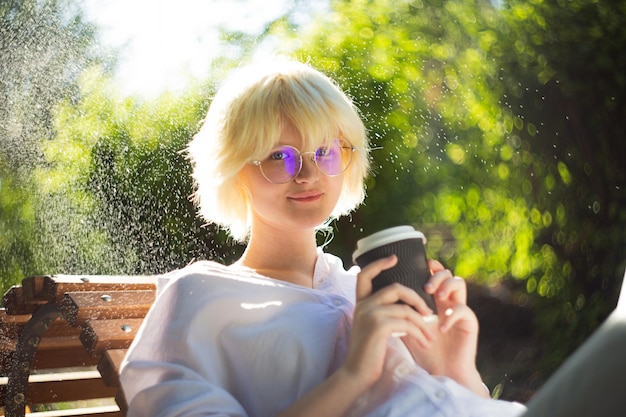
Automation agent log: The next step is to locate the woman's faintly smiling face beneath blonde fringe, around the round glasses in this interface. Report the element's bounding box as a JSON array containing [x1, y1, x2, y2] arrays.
[[241, 123, 343, 233]]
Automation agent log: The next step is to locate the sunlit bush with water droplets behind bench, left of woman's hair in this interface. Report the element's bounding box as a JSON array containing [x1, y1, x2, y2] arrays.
[[37, 68, 244, 274]]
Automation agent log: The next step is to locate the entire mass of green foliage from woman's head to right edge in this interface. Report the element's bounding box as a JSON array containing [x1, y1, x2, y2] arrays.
[[286, 0, 626, 380]]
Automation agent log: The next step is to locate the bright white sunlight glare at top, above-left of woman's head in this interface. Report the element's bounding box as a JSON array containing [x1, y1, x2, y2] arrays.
[[84, 0, 290, 97]]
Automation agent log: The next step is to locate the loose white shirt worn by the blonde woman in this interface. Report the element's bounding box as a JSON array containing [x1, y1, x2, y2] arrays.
[[120, 251, 524, 417]]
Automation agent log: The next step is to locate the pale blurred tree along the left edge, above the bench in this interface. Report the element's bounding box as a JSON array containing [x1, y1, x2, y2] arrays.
[[0, 0, 100, 289]]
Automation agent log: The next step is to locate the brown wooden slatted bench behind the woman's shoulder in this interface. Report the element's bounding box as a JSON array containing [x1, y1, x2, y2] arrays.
[[0, 275, 158, 417]]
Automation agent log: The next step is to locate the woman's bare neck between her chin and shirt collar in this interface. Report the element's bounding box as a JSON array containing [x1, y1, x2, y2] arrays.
[[237, 226, 317, 287]]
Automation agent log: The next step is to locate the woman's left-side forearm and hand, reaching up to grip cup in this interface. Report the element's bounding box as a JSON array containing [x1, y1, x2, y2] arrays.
[[280, 256, 433, 417]]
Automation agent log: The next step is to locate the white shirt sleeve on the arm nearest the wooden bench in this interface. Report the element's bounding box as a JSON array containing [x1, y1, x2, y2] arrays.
[[120, 270, 247, 417]]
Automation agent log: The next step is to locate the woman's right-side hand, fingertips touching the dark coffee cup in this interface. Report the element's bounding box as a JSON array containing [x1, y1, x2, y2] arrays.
[[403, 261, 489, 396]]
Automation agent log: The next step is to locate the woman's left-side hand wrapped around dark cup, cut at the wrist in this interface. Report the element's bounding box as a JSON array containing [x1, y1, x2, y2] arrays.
[[336, 256, 434, 387]]
